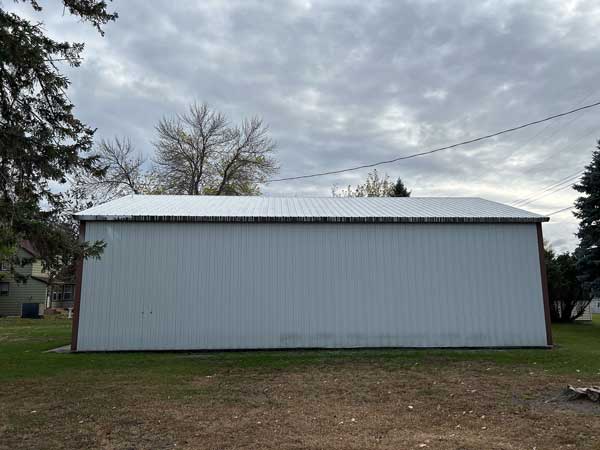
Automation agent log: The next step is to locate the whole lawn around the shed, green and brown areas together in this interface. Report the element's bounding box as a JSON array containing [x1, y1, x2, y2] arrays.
[[0, 316, 600, 450]]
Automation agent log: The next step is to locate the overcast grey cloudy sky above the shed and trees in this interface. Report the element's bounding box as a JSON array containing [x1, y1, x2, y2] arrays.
[[5, 0, 600, 249]]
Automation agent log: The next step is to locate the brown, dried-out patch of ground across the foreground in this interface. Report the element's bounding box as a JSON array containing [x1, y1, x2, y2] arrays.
[[0, 363, 600, 450]]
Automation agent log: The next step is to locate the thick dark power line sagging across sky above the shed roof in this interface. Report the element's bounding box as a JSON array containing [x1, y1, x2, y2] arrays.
[[265, 101, 600, 183]]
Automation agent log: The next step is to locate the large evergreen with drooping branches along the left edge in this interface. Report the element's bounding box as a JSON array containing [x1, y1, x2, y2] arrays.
[[0, 0, 117, 276]]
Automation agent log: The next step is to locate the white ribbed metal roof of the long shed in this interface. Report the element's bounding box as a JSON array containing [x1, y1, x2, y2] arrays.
[[75, 195, 549, 223]]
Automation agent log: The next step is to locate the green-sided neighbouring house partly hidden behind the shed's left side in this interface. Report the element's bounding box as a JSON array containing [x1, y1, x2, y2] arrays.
[[0, 241, 48, 316]]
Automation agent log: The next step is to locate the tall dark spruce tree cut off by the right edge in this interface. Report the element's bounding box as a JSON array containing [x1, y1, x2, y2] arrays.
[[573, 141, 600, 296]]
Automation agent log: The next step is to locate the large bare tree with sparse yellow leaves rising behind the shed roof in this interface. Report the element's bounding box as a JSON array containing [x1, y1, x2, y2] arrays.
[[154, 103, 277, 195]]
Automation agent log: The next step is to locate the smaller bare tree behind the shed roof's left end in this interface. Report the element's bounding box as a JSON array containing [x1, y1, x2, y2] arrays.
[[72, 138, 156, 203]]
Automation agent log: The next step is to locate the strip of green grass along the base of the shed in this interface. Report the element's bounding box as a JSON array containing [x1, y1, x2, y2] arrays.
[[0, 315, 600, 381]]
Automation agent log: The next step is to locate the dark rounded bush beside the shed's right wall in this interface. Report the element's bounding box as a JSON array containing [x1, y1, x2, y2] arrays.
[[544, 245, 590, 322]]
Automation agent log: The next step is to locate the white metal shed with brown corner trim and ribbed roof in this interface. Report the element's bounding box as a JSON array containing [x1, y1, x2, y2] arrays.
[[72, 196, 551, 351]]
